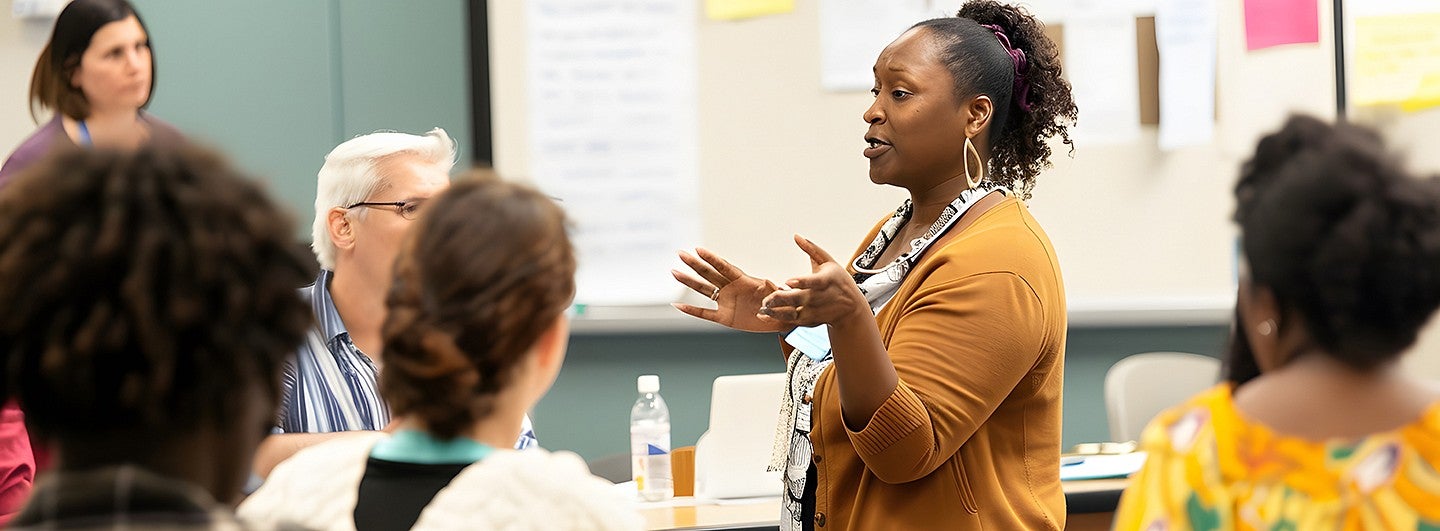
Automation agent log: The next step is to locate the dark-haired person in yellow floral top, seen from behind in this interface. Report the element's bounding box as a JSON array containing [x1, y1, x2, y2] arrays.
[[1115, 117, 1440, 531]]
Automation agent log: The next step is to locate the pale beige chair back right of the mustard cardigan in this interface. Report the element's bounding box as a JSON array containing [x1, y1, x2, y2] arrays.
[[1104, 353, 1220, 440]]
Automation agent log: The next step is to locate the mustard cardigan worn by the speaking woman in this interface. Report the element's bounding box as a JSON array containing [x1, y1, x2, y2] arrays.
[[811, 199, 1066, 531]]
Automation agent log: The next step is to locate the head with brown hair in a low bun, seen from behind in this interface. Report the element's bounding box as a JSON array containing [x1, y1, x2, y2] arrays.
[[380, 173, 576, 437]]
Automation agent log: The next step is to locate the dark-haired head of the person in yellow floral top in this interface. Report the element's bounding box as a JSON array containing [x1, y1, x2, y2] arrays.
[[1231, 117, 1440, 371]]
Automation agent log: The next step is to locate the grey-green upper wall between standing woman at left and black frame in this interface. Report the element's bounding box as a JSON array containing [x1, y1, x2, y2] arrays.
[[134, 0, 471, 233]]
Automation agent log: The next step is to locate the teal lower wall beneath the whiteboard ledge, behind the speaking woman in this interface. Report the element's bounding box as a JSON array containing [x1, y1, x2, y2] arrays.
[[534, 320, 1228, 459]]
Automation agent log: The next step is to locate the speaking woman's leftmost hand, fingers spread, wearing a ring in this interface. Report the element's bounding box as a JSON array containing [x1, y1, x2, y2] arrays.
[[670, 248, 789, 332]]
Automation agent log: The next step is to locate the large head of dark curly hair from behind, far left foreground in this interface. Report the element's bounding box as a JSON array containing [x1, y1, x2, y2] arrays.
[[0, 148, 311, 501]]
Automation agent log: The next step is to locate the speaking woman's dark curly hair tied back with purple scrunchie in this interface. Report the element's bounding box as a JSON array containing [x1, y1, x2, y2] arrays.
[[913, 0, 1077, 199]]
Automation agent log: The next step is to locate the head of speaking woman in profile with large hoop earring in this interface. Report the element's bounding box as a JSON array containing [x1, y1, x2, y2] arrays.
[[863, 0, 1076, 197]]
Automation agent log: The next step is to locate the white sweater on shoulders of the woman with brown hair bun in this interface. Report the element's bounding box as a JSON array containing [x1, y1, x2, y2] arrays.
[[238, 433, 644, 531]]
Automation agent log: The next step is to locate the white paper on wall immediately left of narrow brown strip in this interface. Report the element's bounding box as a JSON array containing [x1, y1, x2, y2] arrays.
[[1061, 9, 1140, 144]]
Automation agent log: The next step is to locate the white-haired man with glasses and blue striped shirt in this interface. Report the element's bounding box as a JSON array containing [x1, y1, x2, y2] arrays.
[[255, 128, 534, 476]]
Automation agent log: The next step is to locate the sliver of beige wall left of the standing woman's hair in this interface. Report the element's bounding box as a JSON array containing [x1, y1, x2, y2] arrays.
[[0, 10, 53, 157]]
